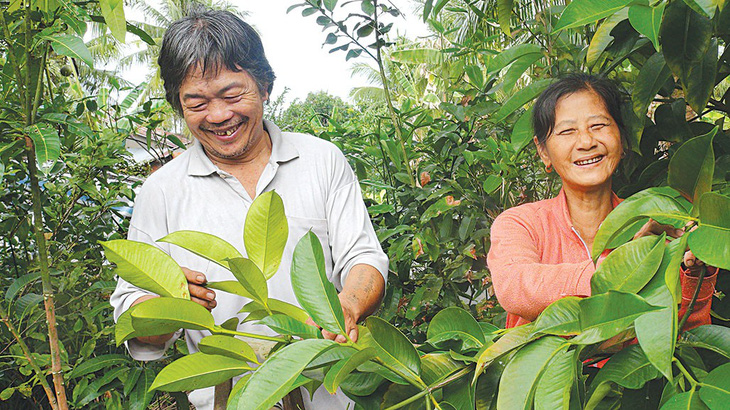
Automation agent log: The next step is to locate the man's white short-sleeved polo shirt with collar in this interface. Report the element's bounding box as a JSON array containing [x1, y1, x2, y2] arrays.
[[110, 120, 388, 406]]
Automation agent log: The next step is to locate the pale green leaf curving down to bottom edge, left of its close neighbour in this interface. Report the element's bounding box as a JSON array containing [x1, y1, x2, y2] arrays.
[[497, 336, 572, 410]]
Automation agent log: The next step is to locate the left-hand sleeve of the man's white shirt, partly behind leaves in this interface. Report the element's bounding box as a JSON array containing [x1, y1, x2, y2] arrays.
[[109, 179, 182, 361]]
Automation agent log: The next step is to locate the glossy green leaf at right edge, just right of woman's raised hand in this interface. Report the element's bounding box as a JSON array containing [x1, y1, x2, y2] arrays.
[[688, 192, 730, 269]]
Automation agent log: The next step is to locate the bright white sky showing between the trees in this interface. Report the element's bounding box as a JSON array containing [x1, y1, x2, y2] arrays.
[[123, 0, 428, 104]]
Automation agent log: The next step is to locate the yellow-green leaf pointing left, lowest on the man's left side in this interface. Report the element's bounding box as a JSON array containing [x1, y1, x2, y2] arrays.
[[151, 352, 251, 391]]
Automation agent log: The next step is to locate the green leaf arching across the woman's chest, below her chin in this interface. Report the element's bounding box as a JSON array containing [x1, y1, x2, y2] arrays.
[[591, 187, 689, 260]]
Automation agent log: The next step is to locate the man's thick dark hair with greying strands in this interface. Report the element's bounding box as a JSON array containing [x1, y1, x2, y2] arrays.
[[157, 6, 276, 115]]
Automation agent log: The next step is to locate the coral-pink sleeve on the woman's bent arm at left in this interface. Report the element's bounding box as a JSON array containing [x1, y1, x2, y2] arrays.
[[487, 212, 595, 321]]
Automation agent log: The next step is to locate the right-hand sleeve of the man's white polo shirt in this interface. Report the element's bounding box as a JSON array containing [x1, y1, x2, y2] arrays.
[[326, 150, 388, 290]]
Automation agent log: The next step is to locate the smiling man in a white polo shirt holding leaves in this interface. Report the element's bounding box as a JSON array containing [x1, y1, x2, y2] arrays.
[[110, 10, 388, 409]]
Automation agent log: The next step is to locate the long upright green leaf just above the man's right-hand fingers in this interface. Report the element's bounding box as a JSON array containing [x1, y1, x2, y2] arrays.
[[291, 231, 347, 335]]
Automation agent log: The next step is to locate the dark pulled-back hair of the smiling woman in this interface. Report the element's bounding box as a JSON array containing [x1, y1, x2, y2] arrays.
[[532, 73, 629, 148]]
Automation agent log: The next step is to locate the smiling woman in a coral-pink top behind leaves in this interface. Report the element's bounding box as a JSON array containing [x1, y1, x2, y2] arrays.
[[488, 74, 717, 329]]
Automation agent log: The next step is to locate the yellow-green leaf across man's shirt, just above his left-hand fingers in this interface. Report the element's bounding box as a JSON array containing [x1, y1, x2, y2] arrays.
[[157, 231, 243, 269]]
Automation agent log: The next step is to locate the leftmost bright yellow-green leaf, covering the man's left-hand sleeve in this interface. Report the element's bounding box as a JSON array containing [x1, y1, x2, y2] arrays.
[[100, 239, 190, 299]]
